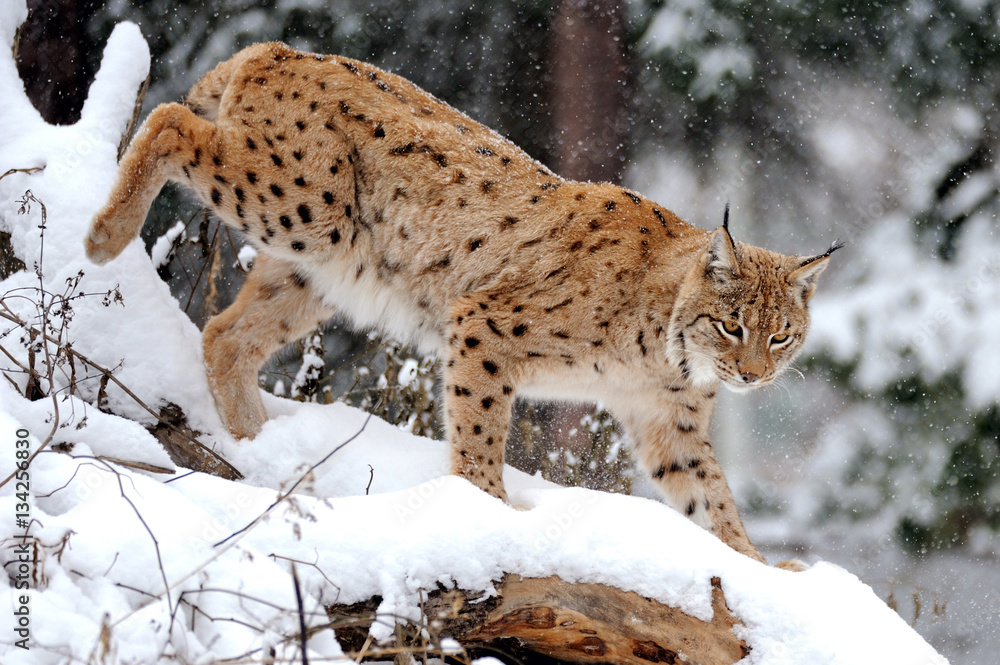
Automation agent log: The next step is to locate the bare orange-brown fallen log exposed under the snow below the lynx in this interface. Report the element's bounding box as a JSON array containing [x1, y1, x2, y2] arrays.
[[328, 575, 749, 665]]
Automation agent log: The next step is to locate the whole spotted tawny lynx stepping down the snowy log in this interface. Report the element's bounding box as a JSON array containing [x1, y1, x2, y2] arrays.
[[86, 43, 837, 561]]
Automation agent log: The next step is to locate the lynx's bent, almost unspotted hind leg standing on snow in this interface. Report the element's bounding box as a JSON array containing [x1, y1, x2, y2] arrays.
[[202, 254, 333, 439]]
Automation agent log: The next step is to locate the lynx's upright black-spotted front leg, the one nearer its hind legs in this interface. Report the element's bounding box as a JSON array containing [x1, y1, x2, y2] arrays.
[[443, 304, 517, 501]]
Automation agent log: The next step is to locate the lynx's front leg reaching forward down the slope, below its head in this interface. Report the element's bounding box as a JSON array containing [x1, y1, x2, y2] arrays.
[[608, 388, 765, 562]]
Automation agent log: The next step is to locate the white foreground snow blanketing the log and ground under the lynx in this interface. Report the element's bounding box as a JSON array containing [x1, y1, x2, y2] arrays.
[[0, 9, 946, 665]]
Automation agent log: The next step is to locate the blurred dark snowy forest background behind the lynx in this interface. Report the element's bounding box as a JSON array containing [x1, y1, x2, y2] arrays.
[[11, 0, 1000, 663]]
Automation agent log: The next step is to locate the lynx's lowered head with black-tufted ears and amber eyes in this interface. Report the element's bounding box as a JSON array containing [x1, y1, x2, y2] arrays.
[[668, 206, 842, 392]]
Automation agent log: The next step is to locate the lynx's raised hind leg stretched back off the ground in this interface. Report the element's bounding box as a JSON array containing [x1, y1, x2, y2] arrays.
[[85, 104, 215, 263]]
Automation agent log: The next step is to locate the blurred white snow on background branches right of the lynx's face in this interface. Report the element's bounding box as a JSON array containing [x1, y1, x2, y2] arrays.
[[809, 215, 1000, 409]]
